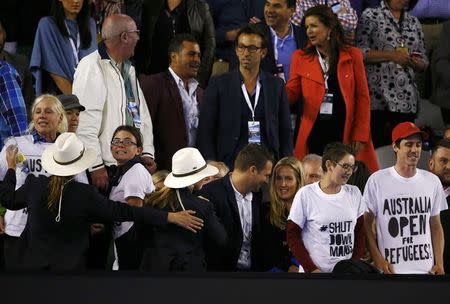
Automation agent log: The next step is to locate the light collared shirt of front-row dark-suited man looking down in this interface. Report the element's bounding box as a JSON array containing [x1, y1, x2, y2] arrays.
[[230, 175, 253, 269]]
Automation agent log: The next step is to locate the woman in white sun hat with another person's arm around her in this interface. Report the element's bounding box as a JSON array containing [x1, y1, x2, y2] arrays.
[[141, 148, 227, 272]]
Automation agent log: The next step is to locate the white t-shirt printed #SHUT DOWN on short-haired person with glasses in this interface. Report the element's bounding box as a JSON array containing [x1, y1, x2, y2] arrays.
[[288, 182, 366, 272]]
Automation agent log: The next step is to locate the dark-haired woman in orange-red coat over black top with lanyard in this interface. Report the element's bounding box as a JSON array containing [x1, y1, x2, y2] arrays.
[[286, 5, 378, 172]]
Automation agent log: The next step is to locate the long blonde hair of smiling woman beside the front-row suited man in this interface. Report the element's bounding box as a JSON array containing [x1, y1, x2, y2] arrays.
[[269, 156, 306, 230]]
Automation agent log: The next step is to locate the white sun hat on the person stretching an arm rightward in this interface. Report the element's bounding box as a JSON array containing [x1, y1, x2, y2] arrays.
[[42, 132, 97, 176]]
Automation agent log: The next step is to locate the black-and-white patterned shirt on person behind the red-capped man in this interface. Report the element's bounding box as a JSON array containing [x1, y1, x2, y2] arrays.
[[356, 1, 428, 113]]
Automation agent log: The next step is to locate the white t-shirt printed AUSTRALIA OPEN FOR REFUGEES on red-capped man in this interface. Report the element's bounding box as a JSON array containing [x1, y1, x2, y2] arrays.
[[363, 167, 447, 274]]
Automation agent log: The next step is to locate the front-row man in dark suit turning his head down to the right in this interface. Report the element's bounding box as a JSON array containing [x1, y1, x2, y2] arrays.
[[201, 144, 273, 271]]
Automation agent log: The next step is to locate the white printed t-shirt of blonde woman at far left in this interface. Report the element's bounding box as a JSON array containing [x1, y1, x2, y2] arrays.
[[0, 135, 88, 237]]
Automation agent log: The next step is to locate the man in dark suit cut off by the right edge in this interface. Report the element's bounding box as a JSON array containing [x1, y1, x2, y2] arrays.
[[428, 139, 450, 273]]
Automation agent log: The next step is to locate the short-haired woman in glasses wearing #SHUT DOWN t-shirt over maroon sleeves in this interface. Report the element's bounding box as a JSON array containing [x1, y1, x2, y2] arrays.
[[287, 142, 366, 272]]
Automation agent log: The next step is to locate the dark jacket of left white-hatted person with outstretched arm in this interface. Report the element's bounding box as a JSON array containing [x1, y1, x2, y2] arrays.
[[0, 169, 167, 271]]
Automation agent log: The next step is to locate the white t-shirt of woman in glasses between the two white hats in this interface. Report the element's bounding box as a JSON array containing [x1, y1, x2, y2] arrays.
[[109, 164, 155, 239]]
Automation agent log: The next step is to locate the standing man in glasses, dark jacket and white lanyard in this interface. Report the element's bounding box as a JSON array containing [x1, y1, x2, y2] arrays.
[[197, 25, 292, 168]]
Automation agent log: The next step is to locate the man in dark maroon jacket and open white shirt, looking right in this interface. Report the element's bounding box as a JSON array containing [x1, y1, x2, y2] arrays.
[[139, 34, 203, 171]]
